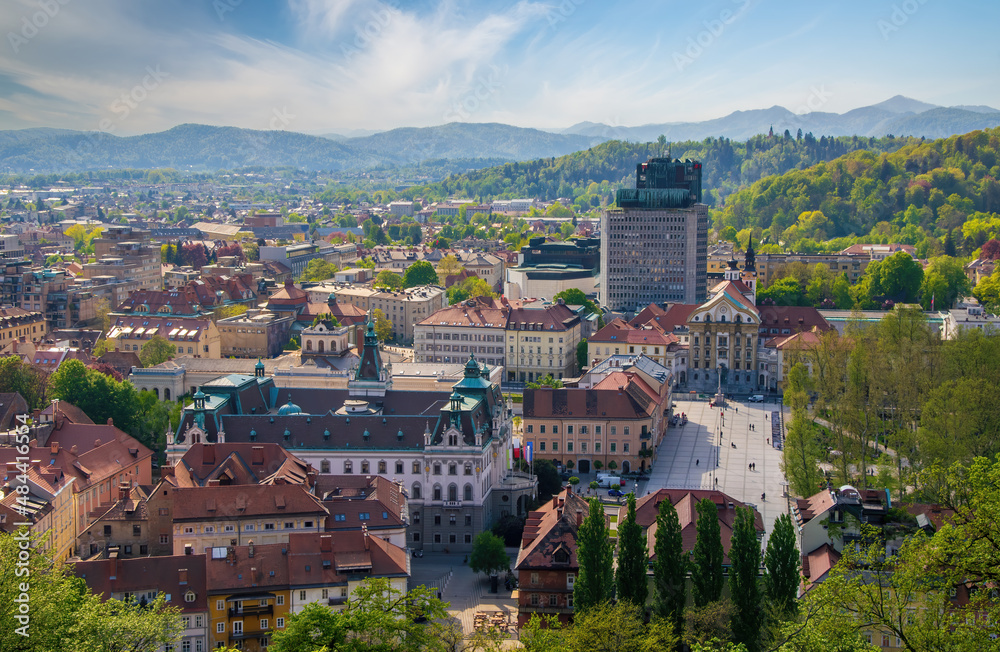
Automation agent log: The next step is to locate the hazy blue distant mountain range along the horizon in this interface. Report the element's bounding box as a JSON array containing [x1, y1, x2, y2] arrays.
[[0, 96, 1000, 173]]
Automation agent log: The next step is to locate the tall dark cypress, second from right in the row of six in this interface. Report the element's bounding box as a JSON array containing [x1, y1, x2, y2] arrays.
[[729, 507, 761, 652]]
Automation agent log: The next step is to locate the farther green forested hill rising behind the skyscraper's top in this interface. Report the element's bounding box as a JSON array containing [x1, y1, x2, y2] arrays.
[[407, 134, 922, 209]]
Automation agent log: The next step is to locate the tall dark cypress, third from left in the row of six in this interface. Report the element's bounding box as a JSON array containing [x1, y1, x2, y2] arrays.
[[653, 500, 688, 636]]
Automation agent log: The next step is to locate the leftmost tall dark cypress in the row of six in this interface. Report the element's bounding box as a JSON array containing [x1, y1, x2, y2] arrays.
[[573, 498, 615, 613]]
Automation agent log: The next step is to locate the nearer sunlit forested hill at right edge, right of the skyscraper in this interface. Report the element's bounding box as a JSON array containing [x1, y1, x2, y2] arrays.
[[720, 128, 1000, 257]]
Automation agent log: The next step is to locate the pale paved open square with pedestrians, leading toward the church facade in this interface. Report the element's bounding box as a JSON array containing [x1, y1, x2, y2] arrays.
[[637, 401, 788, 535]]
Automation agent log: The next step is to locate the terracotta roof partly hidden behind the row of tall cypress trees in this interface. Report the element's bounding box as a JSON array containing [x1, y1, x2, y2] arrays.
[[632, 489, 764, 565]]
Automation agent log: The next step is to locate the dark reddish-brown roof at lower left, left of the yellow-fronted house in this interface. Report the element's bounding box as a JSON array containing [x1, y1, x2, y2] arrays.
[[73, 555, 208, 612]]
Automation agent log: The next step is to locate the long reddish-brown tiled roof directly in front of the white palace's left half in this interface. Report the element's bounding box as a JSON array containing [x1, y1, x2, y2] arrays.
[[171, 484, 327, 522]]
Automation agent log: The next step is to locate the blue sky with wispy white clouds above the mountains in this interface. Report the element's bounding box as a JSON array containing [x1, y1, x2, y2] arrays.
[[0, 0, 1000, 135]]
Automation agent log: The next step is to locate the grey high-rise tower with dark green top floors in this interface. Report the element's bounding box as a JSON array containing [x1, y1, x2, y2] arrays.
[[600, 158, 708, 312]]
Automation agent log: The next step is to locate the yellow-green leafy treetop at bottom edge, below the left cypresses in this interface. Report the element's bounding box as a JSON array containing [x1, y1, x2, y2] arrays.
[[567, 602, 678, 652]]
